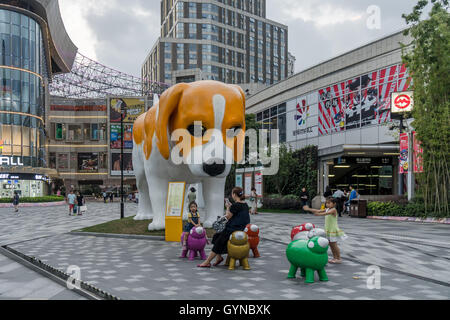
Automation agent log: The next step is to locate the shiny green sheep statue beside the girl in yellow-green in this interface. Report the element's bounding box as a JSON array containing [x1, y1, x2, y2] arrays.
[[286, 237, 329, 283]]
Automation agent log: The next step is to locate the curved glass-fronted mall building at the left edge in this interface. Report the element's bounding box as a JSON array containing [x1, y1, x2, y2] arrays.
[[0, 0, 77, 197]]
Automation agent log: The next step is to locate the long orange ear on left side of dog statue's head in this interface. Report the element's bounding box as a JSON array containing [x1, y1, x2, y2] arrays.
[[156, 83, 189, 160]]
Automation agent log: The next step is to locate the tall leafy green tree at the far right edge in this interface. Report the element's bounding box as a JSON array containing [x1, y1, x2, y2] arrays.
[[403, 0, 450, 215]]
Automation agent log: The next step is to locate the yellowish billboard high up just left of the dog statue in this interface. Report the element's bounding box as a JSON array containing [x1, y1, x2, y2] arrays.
[[109, 98, 145, 123]]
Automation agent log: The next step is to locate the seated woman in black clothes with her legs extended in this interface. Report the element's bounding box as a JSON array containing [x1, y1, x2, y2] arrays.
[[198, 187, 250, 268]]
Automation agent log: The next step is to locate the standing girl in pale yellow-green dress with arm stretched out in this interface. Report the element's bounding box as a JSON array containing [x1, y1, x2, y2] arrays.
[[303, 197, 347, 263]]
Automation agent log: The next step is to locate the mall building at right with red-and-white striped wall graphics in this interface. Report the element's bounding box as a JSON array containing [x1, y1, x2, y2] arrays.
[[247, 32, 411, 199]]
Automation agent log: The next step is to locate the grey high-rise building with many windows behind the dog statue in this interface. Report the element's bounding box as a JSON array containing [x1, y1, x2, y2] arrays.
[[142, 0, 288, 86]]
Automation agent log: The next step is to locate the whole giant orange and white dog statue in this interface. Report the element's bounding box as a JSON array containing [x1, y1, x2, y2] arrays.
[[133, 81, 245, 230]]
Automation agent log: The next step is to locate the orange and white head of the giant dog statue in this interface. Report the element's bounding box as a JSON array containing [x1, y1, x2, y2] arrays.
[[156, 81, 245, 177]]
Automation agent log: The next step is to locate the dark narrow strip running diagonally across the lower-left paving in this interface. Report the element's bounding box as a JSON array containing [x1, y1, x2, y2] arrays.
[[0, 246, 120, 300]]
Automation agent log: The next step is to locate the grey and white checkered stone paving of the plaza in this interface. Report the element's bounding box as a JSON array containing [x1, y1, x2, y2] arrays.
[[0, 203, 450, 300]]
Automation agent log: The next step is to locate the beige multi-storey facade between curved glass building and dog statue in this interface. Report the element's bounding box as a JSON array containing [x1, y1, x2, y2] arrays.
[[48, 97, 146, 195]]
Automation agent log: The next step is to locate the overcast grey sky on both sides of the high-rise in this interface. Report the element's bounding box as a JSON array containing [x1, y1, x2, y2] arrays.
[[59, 0, 426, 76]]
